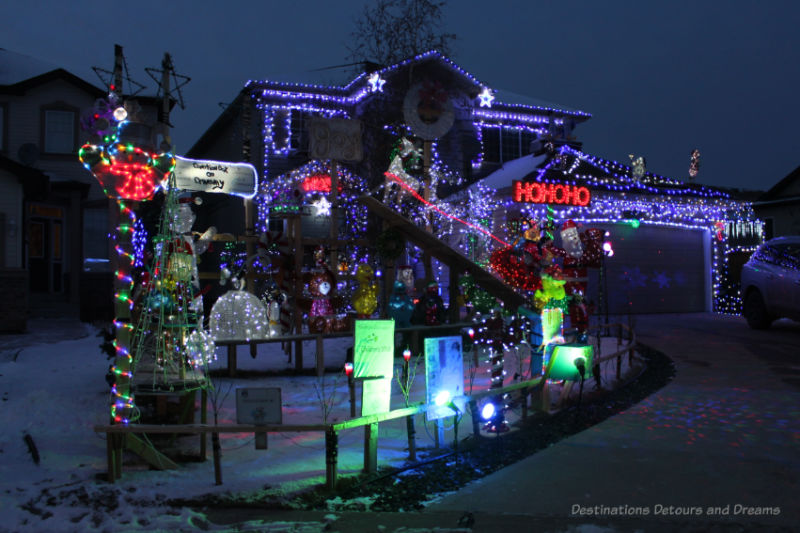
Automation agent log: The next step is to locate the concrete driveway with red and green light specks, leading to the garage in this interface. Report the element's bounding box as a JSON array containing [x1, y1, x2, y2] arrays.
[[424, 314, 800, 531]]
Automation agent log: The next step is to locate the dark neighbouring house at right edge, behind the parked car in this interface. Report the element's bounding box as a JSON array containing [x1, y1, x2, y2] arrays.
[[753, 167, 800, 239]]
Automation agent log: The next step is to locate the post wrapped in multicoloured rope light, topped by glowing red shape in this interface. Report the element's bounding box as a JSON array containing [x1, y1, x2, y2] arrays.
[[78, 92, 175, 424]]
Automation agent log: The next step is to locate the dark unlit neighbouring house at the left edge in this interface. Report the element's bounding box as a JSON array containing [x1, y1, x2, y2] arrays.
[[0, 48, 166, 320]]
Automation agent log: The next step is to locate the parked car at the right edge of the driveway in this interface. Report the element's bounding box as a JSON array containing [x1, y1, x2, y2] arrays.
[[742, 236, 800, 329]]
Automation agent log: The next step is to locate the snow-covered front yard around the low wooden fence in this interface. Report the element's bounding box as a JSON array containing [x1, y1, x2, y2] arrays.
[[0, 322, 636, 532]]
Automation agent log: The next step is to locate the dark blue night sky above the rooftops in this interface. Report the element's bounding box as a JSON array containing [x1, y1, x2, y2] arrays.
[[0, 0, 800, 190]]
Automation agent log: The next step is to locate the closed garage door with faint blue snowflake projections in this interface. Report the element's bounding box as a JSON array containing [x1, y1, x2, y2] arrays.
[[585, 224, 709, 314]]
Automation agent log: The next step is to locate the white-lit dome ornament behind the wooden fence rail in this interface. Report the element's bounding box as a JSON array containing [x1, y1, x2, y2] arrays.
[[208, 291, 268, 341]]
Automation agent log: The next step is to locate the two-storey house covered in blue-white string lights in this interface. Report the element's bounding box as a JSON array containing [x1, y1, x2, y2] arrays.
[[189, 51, 760, 322]]
